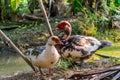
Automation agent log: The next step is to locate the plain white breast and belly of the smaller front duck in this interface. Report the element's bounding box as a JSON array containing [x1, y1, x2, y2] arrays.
[[37, 47, 60, 68]]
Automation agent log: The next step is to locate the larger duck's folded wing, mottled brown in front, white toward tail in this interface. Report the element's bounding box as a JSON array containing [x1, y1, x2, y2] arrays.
[[68, 35, 101, 52]]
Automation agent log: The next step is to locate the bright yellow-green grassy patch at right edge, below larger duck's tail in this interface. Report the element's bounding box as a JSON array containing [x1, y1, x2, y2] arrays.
[[96, 42, 120, 57]]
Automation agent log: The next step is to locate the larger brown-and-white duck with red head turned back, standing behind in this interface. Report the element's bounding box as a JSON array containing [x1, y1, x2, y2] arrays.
[[56, 21, 112, 61]]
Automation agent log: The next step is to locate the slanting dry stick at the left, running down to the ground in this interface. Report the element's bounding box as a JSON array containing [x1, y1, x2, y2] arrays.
[[0, 29, 35, 71]]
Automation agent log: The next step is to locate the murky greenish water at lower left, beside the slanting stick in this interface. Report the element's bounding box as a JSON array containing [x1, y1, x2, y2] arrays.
[[0, 55, 32, 75]]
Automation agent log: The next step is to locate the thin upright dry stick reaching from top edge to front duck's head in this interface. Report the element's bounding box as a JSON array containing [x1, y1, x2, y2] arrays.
[[38, 0, 53, 36]]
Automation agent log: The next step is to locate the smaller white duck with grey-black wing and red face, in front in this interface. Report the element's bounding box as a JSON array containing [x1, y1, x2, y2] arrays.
[[26, 36, 62, 74]]
